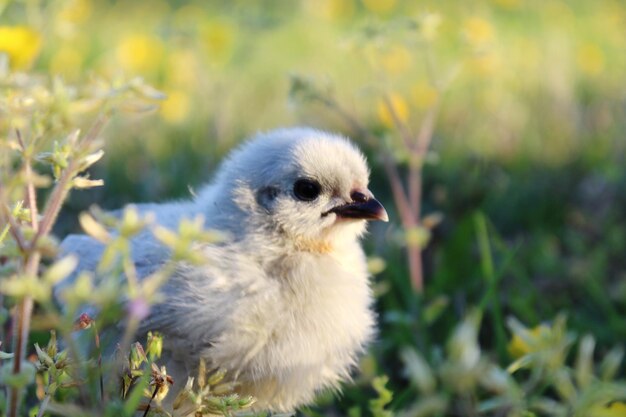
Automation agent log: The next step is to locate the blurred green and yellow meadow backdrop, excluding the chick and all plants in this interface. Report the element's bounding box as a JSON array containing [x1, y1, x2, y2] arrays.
[[0, 0, 626, 413]]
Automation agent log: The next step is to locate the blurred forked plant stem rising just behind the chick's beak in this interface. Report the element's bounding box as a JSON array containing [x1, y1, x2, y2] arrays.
[[290, 13, 456, 293]]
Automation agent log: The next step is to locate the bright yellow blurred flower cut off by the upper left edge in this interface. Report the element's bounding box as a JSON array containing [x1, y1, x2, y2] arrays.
[[0, 26, 41, 70]]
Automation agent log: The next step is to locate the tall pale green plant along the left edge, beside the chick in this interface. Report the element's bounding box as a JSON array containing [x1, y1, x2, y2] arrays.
[[0, 62, 158, 417]]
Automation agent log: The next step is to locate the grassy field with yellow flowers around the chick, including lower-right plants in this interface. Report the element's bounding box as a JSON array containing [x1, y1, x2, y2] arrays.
[[0, 0, 626, 417]]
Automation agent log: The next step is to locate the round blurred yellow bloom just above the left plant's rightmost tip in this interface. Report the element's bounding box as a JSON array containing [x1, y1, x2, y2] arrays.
[[116, 34, 164, 73]]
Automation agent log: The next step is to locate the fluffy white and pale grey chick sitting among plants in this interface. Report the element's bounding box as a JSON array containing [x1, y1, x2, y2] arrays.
[[63, 128, 387, 411]]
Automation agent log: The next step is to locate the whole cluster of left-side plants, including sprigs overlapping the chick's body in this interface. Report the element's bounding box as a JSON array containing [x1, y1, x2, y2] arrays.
[[0, 68, 241, 417]]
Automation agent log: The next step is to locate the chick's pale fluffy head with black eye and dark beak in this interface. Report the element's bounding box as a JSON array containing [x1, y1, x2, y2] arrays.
[[218, 128, 387, 247]]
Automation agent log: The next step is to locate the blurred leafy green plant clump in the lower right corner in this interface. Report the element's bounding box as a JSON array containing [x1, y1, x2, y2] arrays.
[[386, 310, 626, 417]]
